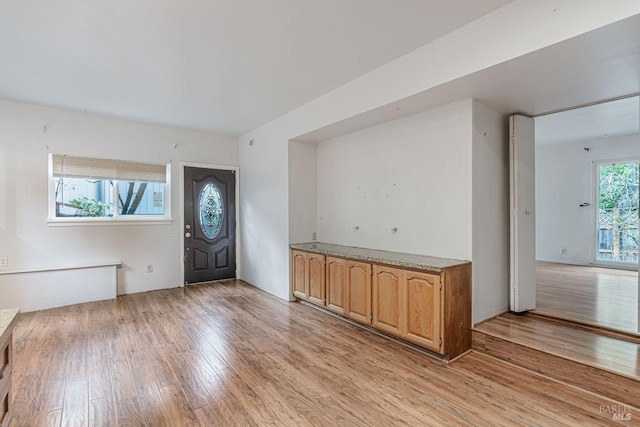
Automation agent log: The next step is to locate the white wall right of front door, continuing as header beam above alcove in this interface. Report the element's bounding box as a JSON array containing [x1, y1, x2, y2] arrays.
[[240, 0, 640, 321]]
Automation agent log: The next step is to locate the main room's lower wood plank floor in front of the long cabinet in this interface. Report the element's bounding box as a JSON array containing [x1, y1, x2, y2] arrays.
[[12, 281, 640, 427]]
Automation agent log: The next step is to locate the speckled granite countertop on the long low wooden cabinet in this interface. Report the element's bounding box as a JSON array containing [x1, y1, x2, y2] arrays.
[[290, 242, 469, 273]]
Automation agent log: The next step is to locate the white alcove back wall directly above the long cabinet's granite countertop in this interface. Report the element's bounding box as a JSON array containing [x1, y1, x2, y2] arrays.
[[318, 100, 471, 260]]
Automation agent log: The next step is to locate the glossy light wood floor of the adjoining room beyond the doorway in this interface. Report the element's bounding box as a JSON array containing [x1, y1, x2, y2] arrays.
[[535, 262, 639, 334]]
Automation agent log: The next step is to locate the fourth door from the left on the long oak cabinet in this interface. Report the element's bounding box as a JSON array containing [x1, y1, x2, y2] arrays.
[[346, 261, 371, 325]]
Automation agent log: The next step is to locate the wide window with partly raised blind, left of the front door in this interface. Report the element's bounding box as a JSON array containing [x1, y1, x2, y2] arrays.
[[49, 154, 171, 222]]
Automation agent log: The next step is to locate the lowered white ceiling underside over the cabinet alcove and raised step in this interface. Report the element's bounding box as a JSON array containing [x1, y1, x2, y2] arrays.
[[296, 15, 640, 143]]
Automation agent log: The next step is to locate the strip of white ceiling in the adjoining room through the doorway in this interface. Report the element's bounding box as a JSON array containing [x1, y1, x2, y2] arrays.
[[535, 96, 640, 145]]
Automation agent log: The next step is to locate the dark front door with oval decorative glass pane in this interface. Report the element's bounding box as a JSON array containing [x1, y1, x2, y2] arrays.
[[183, 167, 236, 284]]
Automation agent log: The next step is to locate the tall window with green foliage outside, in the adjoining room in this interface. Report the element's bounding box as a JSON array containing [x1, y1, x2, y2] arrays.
[[596, 162, 638, 263]]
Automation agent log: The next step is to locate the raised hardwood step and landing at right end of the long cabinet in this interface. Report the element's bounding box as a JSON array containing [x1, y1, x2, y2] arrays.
[[473, 313, 640, 407]]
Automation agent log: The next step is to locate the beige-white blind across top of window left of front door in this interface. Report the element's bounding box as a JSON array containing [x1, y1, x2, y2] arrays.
[[52, 154, 167, 183]]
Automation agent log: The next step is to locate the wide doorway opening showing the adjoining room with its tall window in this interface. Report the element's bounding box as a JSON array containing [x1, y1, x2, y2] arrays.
[[534, 97, 640, 334]]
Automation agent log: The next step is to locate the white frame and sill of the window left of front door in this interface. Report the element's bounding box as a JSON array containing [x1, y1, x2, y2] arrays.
[[47, 153, 173, 226]]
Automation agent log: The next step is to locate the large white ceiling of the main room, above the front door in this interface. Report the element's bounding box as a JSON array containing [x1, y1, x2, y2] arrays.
[[0, 0, 509, 134]]
